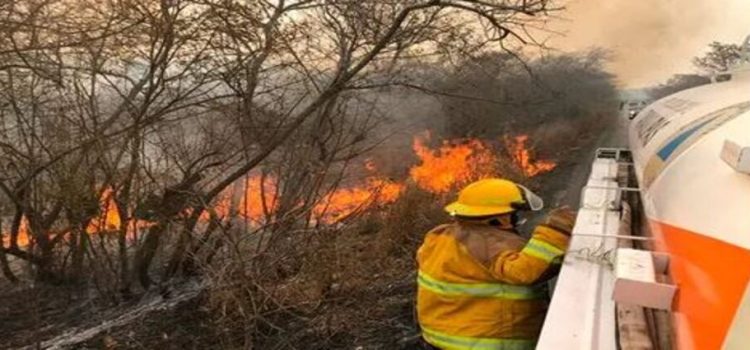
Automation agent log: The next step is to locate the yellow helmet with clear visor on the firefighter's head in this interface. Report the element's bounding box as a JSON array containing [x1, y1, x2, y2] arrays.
[[445, 179, 544, 217]]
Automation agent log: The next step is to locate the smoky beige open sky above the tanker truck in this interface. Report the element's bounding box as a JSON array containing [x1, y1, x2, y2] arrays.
[[548, 0, 750, 87]]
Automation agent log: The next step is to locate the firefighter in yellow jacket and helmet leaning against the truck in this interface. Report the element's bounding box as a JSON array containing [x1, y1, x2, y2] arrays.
[[417, 179, 575, 350]]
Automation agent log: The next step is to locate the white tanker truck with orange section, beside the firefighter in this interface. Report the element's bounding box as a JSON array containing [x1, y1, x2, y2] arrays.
[[537, 37, 750, 350]]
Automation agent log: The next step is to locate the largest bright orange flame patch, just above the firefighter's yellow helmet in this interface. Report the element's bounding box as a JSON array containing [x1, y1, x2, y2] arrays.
[[409, 135, 496, 193]]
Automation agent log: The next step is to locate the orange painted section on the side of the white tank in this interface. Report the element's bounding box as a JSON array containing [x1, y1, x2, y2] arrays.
[[652, 221, 750, 350]]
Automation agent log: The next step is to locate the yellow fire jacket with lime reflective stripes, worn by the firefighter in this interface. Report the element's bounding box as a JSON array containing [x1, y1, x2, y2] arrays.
[[417, 223, 569, 350]]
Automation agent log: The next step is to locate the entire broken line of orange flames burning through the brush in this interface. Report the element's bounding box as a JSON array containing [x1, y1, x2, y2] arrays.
[[2, 134, 557, 238]]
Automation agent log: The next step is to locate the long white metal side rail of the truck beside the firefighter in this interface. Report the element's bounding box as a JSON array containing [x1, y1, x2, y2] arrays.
[[537, 159, 620, 350]]
